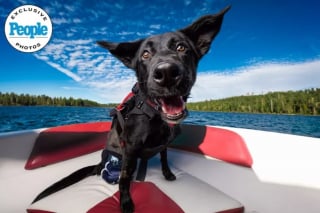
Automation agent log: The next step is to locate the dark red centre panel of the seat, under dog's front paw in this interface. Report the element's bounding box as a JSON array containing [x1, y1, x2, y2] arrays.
[[87, 182, 183, 213]]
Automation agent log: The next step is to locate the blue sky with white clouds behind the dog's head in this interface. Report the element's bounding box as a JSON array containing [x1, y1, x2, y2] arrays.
[[0, 0, 320, 103]]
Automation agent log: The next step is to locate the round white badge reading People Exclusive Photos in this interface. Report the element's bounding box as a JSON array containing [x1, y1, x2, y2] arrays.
[[5, 5, 52, 52]]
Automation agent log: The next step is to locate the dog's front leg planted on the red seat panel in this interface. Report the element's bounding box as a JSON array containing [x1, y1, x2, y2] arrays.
[[119, 153, 137, 213]]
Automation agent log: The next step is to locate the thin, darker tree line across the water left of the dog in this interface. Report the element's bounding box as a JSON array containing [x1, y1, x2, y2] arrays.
[[0, 92, 101, 107]]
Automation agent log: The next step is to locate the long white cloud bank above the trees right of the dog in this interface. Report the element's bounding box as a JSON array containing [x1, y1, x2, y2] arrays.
[[190, 60, 320, 102]]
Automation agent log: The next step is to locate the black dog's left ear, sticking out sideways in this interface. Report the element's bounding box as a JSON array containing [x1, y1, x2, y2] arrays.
[[97, 40, 143, 68]]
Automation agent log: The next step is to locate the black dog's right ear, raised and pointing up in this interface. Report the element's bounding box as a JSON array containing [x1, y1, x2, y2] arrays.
[[180, 6, 231, 58]]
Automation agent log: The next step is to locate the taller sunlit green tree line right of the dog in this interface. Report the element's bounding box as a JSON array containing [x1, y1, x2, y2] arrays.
[[188, 88, 320, 115]]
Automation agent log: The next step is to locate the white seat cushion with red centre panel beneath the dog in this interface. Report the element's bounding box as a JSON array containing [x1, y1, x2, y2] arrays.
[[27, 158, 244, 213]]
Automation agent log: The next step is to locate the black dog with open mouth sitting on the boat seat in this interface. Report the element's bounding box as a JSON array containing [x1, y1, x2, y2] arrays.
[[31, 7, 230, 213]]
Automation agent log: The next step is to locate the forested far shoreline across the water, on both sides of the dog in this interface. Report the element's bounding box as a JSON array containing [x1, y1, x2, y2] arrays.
[[0, 88, 320, 116]]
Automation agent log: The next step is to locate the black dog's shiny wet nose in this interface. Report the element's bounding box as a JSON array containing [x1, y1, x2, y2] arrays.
[[153, 62, 182, 86]]
